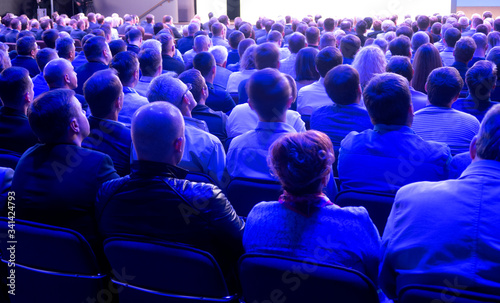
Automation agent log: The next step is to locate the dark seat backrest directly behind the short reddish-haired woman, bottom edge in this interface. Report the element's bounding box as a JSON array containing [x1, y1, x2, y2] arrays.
[[239, 254, 379, 303]]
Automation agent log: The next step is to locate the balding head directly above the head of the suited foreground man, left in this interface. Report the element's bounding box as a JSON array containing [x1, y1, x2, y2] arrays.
[[43, 58, 77, 89]]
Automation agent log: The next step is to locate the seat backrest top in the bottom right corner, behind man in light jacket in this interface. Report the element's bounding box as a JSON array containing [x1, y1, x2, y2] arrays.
[[398, 285, 500, 303]]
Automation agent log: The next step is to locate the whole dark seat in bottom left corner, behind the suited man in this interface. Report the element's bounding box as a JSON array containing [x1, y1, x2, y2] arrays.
[[0, 218, 109, 303]]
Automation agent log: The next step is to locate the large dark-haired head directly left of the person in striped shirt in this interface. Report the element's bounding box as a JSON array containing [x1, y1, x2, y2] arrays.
[[363, 73, 411, 125]]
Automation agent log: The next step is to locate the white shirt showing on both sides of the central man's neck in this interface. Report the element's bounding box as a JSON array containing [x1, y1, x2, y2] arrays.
[[226, 103, 306, 138]]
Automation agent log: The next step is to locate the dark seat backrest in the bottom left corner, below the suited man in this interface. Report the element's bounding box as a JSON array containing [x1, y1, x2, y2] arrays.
[[0, 217, 100, 275]]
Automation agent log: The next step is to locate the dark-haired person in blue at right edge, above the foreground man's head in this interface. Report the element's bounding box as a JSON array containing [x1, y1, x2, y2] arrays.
[[451, 60, 497, 121]]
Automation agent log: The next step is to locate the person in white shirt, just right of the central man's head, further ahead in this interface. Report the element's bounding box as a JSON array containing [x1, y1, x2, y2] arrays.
[[297, 47, 344, 115]]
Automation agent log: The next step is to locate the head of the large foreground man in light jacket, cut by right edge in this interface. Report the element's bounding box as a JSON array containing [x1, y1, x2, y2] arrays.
[[476, 104, 500, 161]]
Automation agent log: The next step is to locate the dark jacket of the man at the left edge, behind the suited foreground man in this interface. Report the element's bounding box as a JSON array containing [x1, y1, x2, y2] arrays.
[[0, 106, 38, 155]]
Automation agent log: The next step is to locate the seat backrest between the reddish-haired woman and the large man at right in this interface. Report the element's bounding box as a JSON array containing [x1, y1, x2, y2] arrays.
[[335, 190, 394, 235]]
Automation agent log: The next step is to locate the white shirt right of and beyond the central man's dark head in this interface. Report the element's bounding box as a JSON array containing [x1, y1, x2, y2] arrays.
[[297, 77, 333, 115]]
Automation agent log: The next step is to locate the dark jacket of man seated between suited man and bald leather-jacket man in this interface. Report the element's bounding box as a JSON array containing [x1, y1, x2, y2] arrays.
[[82, 116, 132, 177]]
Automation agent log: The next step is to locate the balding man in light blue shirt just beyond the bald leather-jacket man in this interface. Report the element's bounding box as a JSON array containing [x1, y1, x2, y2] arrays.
[[147, 74, 229, 188]]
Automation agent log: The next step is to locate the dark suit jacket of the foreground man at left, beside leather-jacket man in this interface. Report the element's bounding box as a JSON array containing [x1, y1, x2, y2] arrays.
[[12, 144, 119, 251]]
